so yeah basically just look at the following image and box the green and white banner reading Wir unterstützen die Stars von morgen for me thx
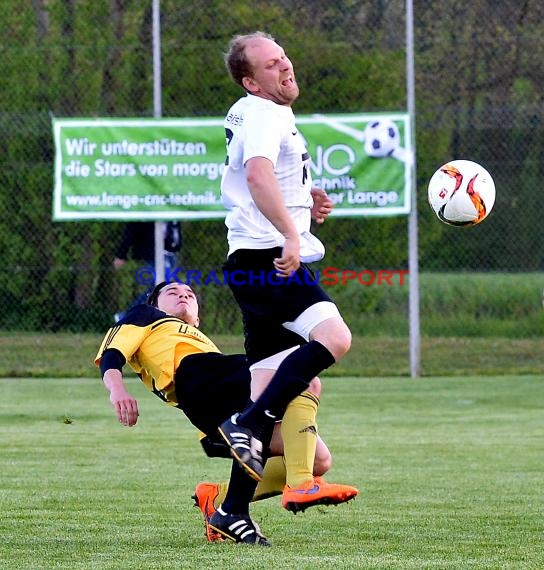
[53,113,412,221]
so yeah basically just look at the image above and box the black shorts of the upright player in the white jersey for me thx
[223,247,331,364]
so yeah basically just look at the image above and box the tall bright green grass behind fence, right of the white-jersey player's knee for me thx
[327,271,544,339]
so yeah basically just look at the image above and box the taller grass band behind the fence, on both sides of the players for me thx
[4,270,544,339]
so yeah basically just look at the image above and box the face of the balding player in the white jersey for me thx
[244,38,299,105]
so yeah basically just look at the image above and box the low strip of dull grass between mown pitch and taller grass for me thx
[0,332,544,378]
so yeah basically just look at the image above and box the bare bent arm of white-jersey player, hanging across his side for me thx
[245,156,300,277]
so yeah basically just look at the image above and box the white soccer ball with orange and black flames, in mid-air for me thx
[428,160,495,226]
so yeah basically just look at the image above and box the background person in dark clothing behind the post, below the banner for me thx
[113,222,182,322]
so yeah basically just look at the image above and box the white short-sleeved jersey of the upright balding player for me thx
[221,95,325,262]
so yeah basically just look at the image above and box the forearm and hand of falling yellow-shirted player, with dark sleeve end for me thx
[100,349,138,427]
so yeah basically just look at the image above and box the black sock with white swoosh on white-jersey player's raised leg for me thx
[237,340,335,435]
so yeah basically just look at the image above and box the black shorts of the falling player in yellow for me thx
[176,352,251,436]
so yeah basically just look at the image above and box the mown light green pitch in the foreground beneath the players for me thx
[0,375,544,570]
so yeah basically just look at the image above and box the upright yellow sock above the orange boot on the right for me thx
[281,392,319,487]
